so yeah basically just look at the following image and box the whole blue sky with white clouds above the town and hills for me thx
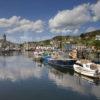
[0,0,100,43]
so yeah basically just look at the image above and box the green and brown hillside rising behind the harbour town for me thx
[22,30,100,45]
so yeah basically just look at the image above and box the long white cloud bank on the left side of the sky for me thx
[0,16,44,33]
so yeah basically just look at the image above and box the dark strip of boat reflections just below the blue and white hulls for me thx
[47,63,100,85]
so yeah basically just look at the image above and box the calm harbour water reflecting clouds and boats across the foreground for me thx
[0,51,100,100]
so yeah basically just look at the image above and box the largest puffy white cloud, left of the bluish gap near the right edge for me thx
[49,4,92,33]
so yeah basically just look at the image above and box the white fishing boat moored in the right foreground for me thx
[73,60,100,78]
